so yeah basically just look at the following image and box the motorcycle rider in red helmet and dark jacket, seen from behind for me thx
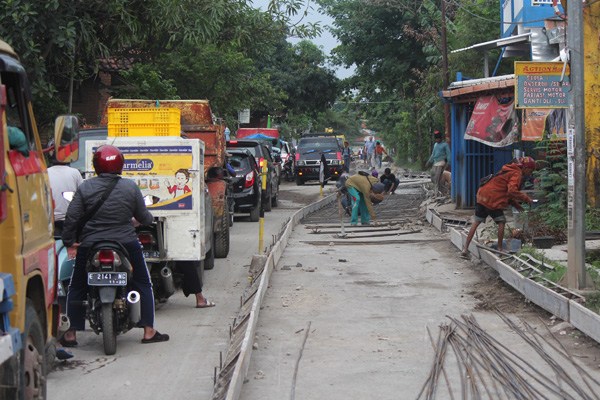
[61,145,169,347]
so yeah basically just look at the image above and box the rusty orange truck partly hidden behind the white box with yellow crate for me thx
[102,98,233,258]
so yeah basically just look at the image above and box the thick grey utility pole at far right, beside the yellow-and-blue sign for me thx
[567,0,586,290]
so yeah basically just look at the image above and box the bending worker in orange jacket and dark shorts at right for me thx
[461,157,535,258]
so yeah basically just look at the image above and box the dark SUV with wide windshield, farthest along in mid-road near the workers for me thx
[296,136,344,185]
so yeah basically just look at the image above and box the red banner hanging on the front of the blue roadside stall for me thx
[465,96,518,147]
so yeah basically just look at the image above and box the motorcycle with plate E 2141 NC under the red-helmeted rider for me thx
[84,241,141,355]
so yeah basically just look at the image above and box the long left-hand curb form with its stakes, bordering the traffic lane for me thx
[211,193,337,400]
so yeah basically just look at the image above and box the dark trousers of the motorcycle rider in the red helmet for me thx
[67,240,154,331]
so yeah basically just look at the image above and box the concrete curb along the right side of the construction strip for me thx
[427,209,600,343]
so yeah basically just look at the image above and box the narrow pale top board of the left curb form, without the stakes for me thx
[225,194,337,400]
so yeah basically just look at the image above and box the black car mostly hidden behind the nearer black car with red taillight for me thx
[227,140,281,211]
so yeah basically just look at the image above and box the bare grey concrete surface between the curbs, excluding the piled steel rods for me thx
[240,182,600,400]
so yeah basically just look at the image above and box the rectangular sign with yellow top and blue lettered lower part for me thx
[515,61,571,108]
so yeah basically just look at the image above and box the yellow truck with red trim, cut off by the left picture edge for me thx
[0,40,62,399]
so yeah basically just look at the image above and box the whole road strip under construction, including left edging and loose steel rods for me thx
[213,175,600,400]
